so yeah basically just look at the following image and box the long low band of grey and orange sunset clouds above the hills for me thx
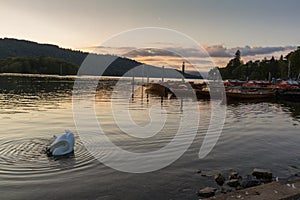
[79,43,297,68]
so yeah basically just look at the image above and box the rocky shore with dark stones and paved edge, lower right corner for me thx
[197,168,300,200]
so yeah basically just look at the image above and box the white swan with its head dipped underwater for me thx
[46,130,75,156]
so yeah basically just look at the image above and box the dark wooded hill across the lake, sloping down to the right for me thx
[0,38,199,78]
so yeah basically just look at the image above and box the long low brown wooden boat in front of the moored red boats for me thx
[226,87,275,100]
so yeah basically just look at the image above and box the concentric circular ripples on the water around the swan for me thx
[0,138,96,178]
